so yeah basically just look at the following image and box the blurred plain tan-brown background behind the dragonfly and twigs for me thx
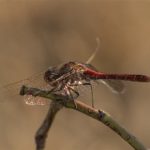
[0,0,150,150]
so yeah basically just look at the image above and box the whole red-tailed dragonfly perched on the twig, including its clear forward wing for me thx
[1,61,150,107]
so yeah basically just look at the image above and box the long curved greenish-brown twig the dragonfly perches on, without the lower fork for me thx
[20,86,146,150]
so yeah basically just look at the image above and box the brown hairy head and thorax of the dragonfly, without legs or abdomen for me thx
[44,62,85,88]
